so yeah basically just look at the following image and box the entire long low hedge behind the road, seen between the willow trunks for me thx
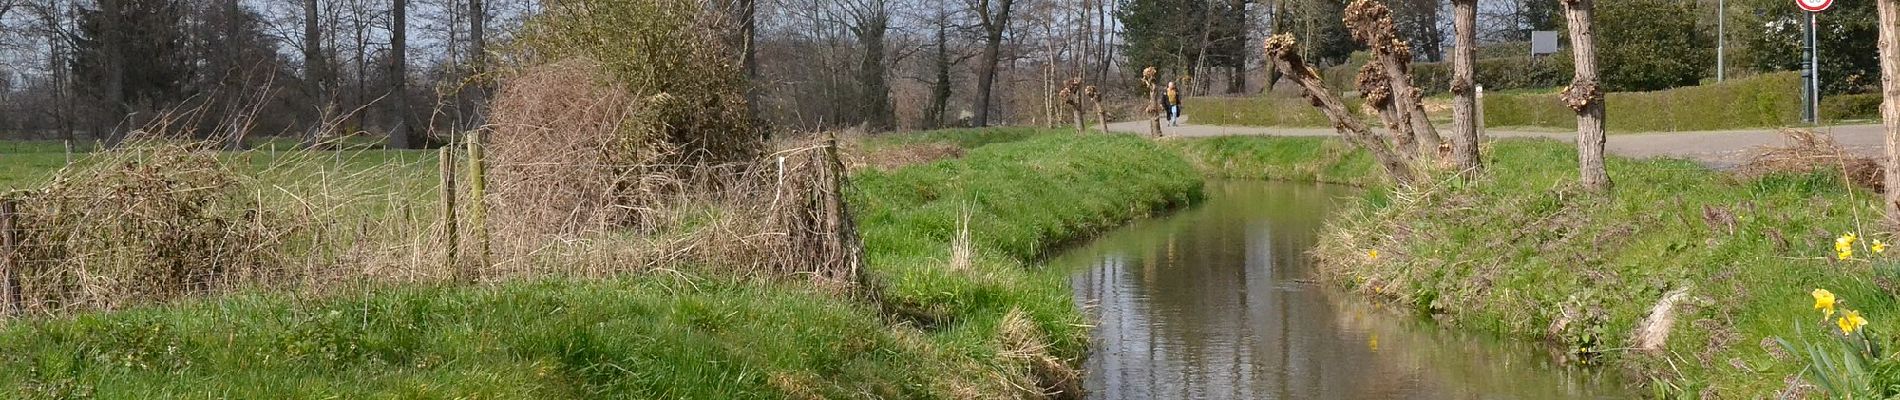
[1184,72,1801,133]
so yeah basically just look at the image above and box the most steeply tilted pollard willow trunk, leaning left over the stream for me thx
[1262,34,1414,186]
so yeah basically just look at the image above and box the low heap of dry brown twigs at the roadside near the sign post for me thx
[1735,129,1887,191]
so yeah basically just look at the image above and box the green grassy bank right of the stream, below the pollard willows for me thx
[1176,138,1900,398]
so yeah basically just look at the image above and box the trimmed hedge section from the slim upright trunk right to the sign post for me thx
[1484,72,1801,133]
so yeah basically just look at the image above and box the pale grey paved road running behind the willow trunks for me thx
[1108,121,1881,169]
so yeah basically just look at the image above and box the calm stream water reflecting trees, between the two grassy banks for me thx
[1055,182,1628,398]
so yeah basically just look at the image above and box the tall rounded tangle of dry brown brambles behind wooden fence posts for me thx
[485,59,676,254]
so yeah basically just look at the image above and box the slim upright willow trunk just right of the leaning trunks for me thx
[1452,0,1484,174]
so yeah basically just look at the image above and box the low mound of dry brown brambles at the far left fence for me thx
[11,142,281,313]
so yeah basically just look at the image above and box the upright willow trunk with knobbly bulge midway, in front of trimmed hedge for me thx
[1564,0,1609,191]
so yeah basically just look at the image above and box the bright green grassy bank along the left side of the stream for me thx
[0,133,1201,398]
